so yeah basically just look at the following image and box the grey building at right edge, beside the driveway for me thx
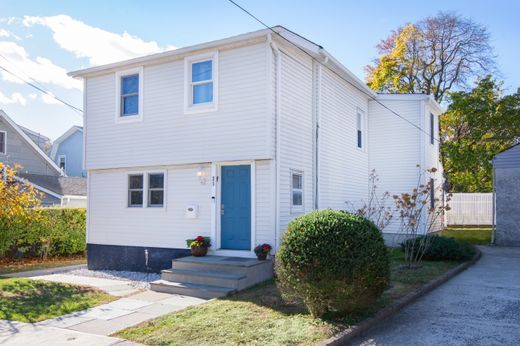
[493,144,520,246]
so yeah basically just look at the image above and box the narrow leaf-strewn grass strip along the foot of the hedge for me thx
[0,256,86,275]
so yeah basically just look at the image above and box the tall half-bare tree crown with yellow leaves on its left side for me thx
[366,12,495,102]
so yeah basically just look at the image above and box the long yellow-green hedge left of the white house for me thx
[0,208,86,258]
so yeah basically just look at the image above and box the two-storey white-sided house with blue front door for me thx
[71,26,442,271]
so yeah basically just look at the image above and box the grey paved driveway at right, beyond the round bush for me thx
[353,247,520,346]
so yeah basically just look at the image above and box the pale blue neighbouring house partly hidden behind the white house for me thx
[50,126,87,177]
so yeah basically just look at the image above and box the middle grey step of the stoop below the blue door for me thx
[161,268,246,289]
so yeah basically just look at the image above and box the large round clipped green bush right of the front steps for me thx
[276,210,390,317]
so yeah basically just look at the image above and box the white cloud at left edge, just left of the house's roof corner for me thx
[0,41,83,90]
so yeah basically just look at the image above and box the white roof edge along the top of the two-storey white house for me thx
[69,25,376,97]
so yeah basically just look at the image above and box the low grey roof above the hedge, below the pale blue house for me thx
[17,173,87,198]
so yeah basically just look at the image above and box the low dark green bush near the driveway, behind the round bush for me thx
[401,235,476,261]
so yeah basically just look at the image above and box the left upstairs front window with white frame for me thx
[116,68,143,122]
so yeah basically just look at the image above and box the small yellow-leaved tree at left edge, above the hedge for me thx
[0,162,43,256]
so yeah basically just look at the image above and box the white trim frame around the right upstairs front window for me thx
[184,52,219,114]
